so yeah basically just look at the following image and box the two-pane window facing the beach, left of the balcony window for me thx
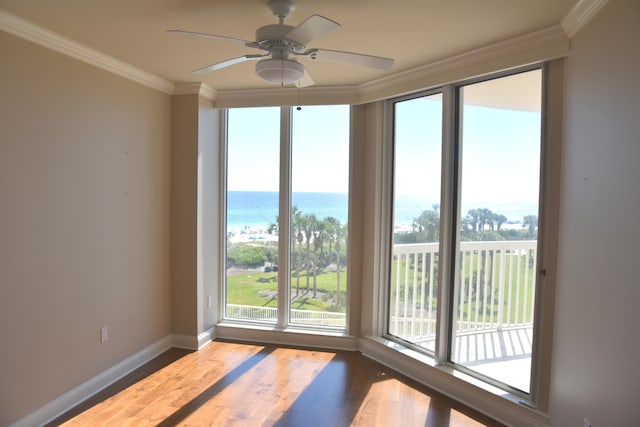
[225,106,350,329]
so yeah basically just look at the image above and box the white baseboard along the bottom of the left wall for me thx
[9,336,173,427]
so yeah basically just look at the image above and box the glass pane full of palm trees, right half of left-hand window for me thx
[289,105,350,328]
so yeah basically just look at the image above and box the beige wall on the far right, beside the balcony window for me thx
[551,0,640,427]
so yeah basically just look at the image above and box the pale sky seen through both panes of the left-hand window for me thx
[228,105,349,193]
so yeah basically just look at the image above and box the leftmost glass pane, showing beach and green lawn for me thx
[225,107,280,323]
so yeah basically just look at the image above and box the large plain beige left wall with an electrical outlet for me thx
[0,33,171,425]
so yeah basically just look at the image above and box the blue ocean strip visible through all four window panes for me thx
[227,191,537,236]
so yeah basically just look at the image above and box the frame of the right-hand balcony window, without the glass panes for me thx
[375,63,557,409]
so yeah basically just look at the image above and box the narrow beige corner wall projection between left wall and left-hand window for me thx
[171,94,221,338]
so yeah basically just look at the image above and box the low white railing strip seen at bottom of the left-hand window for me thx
[226,304,347,327]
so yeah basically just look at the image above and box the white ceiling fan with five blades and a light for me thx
[168,0,394,87]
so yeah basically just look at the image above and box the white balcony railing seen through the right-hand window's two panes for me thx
[389,240,536,343]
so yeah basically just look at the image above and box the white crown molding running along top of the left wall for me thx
[0,9,174,94]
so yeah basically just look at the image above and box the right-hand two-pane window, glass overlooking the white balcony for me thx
[386,69,542,395]
